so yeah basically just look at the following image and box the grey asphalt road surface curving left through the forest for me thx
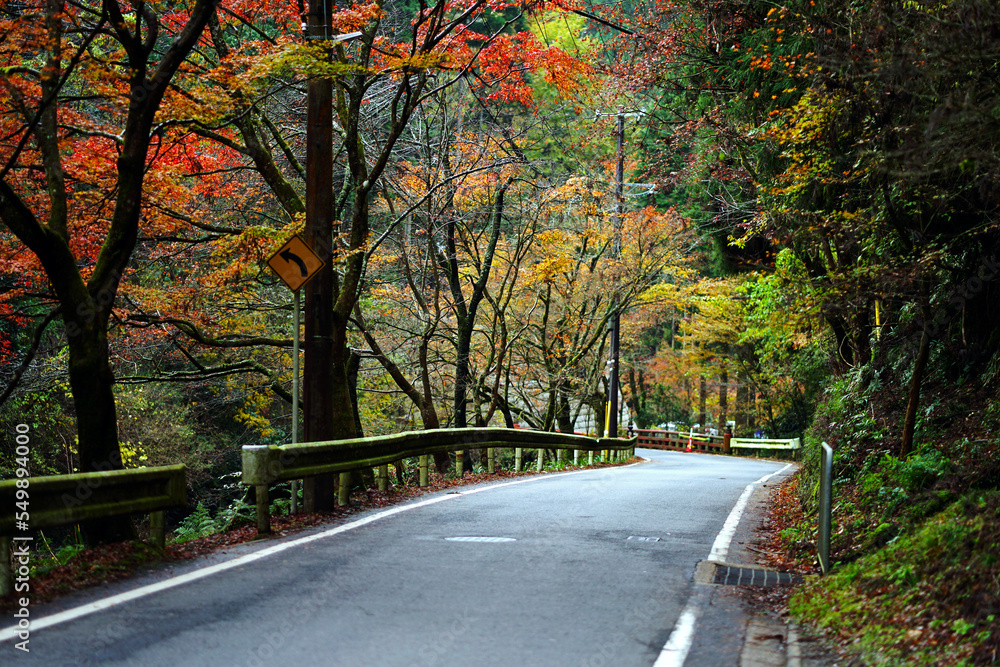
[0,450,782,667]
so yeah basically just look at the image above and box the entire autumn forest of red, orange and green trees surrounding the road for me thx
[0,0,1000,664]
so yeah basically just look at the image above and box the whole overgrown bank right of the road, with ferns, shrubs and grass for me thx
[776,370,1000,665]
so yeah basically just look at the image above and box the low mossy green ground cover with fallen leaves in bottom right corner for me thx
[790,494,1000,665]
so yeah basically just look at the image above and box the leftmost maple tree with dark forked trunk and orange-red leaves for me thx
[0,0,215,540]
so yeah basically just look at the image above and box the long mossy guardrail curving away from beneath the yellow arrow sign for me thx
[242,428,637,533]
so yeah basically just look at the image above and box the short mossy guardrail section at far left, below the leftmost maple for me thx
[0,465,187,595]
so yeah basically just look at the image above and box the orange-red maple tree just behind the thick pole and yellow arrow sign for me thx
[0,3,592,460]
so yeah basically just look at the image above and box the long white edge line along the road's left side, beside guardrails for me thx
[0,463,639,642]
